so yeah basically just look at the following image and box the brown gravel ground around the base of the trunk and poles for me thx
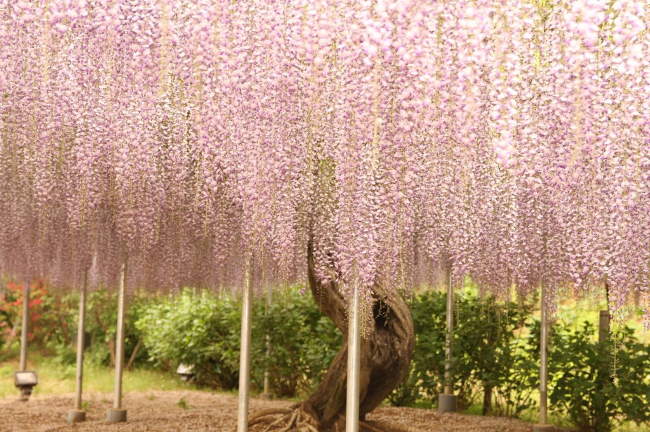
[0,391,532,432]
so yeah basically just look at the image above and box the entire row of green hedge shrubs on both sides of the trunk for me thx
[7,287,650,432]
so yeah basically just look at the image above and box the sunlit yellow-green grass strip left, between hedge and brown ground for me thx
[0,354,195,398]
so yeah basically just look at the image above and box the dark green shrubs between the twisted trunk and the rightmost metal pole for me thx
[389,291,537,415]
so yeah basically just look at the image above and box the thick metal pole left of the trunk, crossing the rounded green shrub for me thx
[237,259,252,432]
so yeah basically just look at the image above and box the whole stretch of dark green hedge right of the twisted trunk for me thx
[389,292,650,432]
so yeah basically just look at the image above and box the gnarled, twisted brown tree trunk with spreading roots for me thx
[251,241,415,432]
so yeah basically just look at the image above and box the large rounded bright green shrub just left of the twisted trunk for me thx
[136,289,342,397]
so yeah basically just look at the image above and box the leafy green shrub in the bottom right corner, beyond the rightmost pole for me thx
[549,322,650,432]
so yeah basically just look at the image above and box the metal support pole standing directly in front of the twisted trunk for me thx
[345,283,361,432]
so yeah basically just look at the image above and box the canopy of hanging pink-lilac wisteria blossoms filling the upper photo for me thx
[0,0,650,322]
